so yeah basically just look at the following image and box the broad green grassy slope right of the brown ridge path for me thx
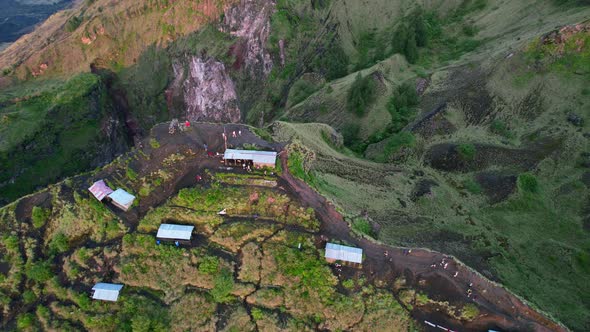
[275,21,590,331]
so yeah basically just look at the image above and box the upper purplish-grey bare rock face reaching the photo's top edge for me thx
[222,0,275,77]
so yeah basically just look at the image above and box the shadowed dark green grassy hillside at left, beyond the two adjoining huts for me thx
[0,74,128,203]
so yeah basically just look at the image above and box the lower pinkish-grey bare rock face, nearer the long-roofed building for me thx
[169,57,241,122]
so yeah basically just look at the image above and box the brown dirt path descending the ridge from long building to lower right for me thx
[280,153,566,331]
